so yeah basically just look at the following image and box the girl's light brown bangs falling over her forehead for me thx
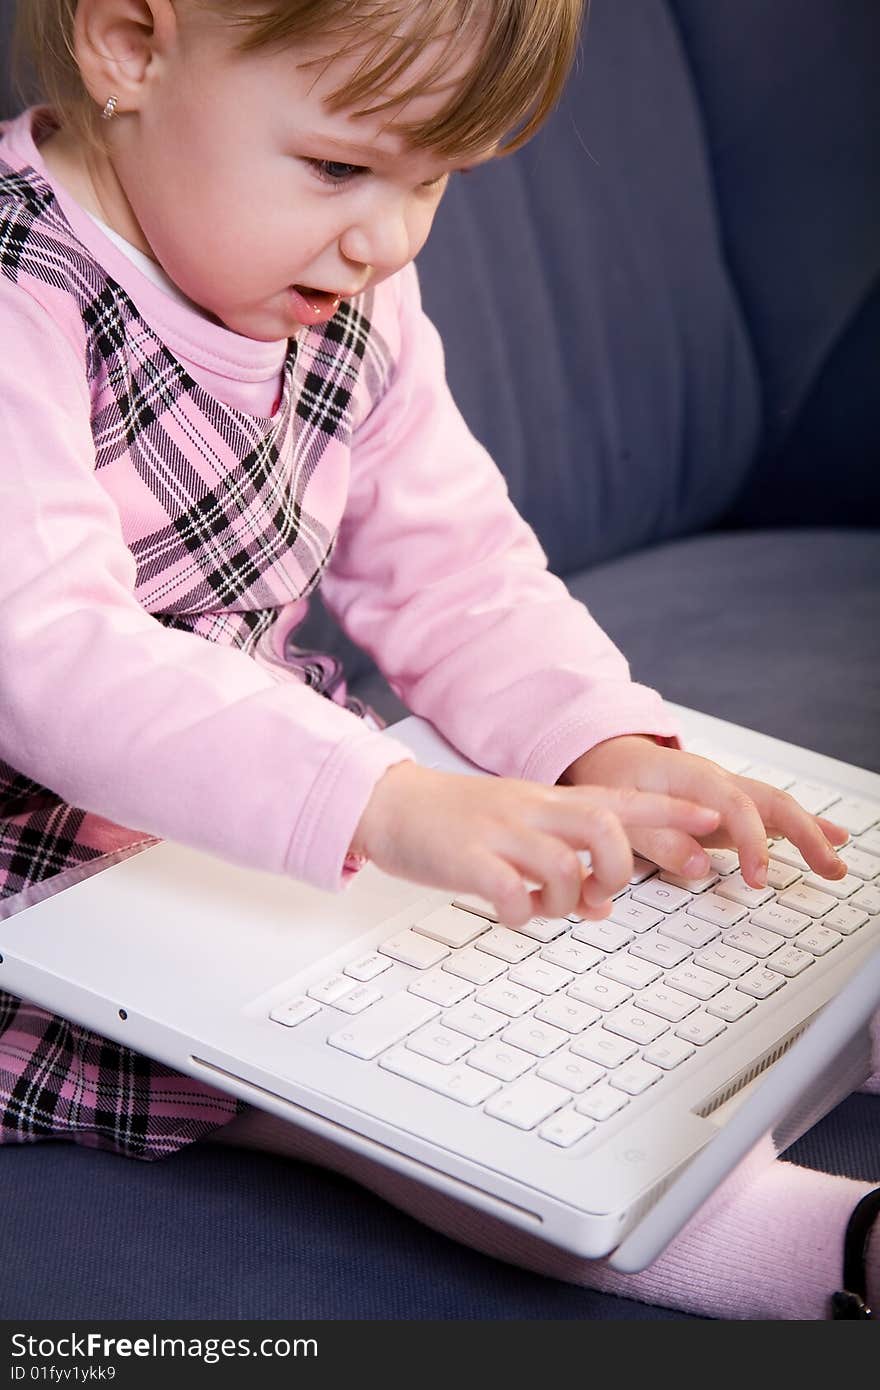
[222,0,584,158]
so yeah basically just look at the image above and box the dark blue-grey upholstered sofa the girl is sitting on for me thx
[0,0,880,1319]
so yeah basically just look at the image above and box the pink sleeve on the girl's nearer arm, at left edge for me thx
[0,282,412,890]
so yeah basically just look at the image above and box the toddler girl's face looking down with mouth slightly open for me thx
[113,21,488,341]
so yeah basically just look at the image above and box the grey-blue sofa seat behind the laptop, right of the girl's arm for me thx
[569,528,880,771]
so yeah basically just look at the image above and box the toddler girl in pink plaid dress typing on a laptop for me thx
[0,0,880,1318]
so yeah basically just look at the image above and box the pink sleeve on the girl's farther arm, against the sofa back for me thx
[321,265,683,783]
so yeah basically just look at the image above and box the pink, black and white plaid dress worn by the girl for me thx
[0,149,393,1159]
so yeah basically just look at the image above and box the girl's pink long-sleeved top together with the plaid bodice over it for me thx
[0,110,681,890]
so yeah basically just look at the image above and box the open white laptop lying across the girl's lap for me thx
[0,705,880,1270]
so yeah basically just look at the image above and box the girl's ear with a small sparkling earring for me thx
[74,0,178,114]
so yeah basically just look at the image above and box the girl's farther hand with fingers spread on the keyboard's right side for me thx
[564,734,848,888]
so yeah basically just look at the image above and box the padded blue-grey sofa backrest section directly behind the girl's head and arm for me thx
[418,0,759,575]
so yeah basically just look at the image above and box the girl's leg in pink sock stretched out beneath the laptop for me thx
[211,1109,880,1321]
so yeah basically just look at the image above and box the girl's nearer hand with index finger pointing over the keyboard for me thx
[352,762,719,927]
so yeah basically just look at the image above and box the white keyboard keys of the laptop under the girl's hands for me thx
[268,742,880,1148]
